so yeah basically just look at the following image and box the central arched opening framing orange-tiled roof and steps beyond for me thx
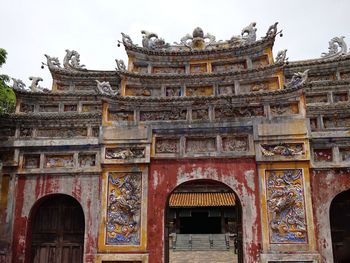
[165,180,243,263]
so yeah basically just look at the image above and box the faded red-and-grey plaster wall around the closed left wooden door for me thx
[12,175,100,263]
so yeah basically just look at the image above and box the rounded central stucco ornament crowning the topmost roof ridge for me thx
[175,27,216,50]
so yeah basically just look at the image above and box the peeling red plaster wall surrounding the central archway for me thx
[148,158,261,263]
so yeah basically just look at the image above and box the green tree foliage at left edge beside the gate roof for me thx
[0,48,16,114]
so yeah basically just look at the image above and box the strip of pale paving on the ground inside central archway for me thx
[169,250,238,263]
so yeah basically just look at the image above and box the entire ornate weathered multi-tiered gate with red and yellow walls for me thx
[0,23,350,263]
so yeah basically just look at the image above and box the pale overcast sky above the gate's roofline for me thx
[0,0,350,88]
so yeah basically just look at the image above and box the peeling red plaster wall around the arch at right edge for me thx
[310,169,350,263]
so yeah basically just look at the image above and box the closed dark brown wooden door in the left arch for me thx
[27,194,85,263]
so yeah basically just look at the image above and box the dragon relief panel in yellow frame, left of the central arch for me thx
[105,172,142,245]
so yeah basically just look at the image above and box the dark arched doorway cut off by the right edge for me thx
[329,190,350,263]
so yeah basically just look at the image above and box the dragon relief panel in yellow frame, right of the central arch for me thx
[265,169,308,244]
